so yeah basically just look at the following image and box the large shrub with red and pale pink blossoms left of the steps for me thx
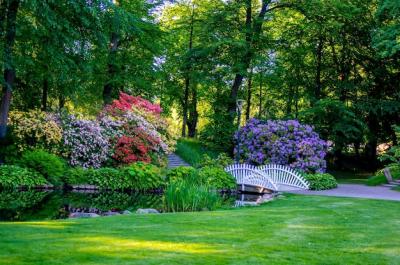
[99,93,172,164]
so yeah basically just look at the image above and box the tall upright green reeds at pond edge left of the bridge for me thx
[163,174,221,212]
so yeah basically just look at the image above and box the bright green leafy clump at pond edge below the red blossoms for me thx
[123,162,164,191]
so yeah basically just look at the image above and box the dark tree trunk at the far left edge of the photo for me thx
[0,0,19,140]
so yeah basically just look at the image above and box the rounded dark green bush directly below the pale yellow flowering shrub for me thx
[18,150,65,184]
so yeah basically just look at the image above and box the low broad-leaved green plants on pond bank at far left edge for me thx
[0,165,47,188]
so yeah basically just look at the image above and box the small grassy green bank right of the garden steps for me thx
[175,138,219,166]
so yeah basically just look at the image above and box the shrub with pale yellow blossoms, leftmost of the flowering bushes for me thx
[9,110,62,153]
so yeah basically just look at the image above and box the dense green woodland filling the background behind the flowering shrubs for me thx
[0,0,400,169]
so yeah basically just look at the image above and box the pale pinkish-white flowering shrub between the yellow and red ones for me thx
[63,116,110,168]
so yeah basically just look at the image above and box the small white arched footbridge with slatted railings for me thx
[225,164,309,191]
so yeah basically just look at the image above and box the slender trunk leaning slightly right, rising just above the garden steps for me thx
[181,5,194,137]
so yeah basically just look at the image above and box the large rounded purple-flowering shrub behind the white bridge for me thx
[235,119,328,172]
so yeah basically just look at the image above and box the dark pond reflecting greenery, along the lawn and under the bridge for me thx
[0,190,272,221]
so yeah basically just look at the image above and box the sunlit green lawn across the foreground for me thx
[0,195,400,265]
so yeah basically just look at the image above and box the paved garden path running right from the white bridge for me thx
[291,184,400,201]
